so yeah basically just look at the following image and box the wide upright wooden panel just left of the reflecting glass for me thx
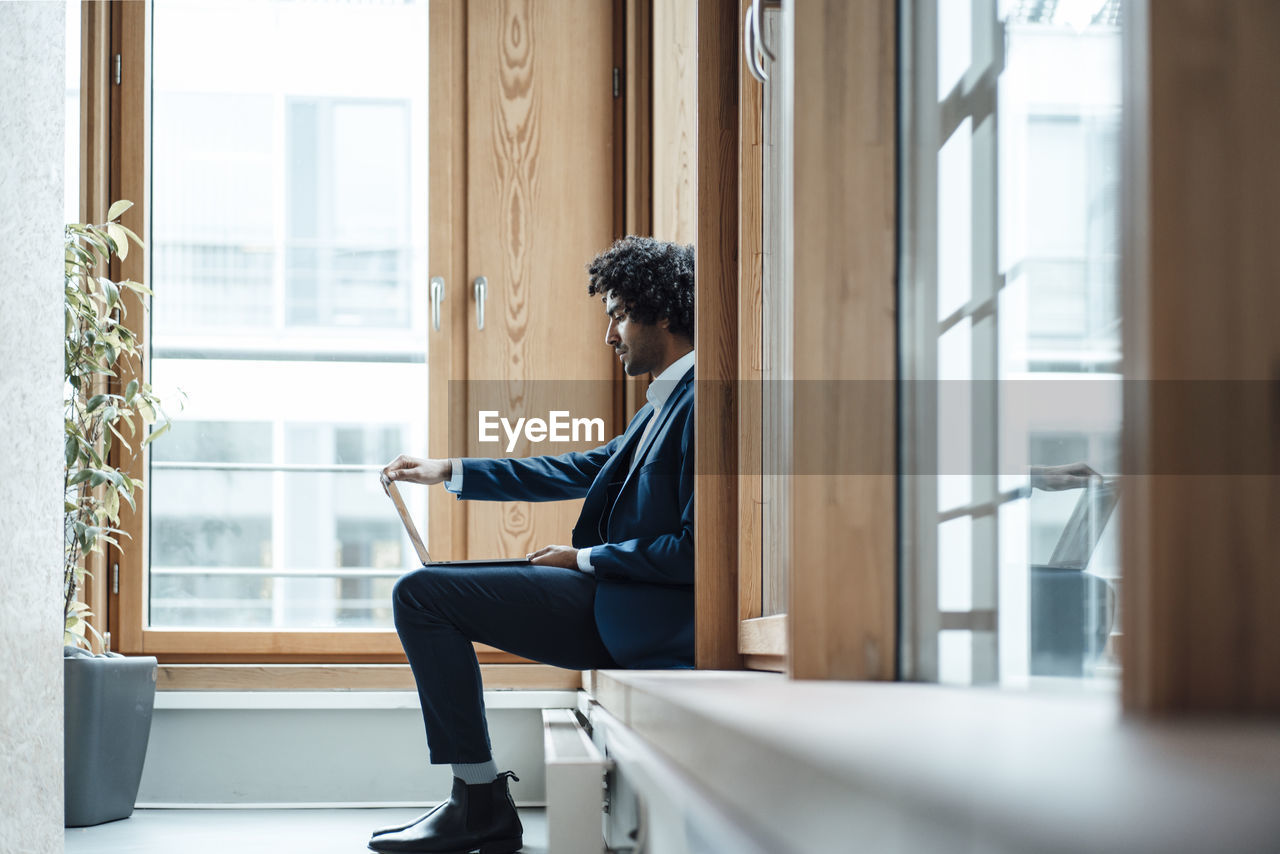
[788,0,896,679]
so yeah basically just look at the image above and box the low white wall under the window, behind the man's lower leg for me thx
[138,691,555,807]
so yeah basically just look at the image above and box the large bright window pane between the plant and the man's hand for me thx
[148,0,428,629]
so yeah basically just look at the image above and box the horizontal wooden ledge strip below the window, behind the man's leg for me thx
[156,665,582,691]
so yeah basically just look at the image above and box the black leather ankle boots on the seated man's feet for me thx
[369,771,525,854]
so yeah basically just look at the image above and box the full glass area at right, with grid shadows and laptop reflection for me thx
[900,0,1123,685]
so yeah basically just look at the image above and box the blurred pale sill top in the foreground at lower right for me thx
[591,671,1280,853]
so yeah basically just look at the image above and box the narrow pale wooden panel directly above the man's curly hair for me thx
[653,0,699,243]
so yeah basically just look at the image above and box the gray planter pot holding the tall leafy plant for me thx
[63,656,156,827]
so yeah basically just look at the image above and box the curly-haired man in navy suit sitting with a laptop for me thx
[369,237,694,854]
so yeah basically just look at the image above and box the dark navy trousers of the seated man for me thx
[392,563,617,763]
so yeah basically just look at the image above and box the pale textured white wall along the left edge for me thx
[0,1,65,854]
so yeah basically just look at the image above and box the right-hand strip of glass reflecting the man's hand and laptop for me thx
[1000,1,1121,681]
